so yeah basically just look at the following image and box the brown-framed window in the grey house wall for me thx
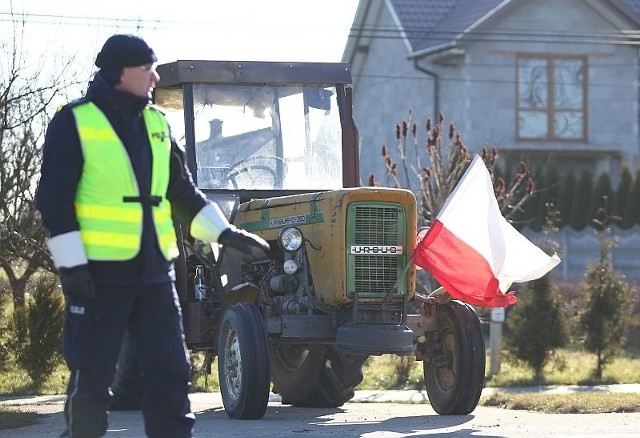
[516,55,587,141]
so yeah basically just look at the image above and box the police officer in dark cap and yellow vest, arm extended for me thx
[36,34,269,438]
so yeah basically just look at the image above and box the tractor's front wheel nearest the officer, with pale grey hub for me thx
[218,302,270,420]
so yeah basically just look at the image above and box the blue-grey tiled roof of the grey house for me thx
[388,0,640,56]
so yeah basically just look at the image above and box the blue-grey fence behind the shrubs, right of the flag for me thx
[522,225,640,284]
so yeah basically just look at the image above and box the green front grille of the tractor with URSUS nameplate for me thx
[347,203,406,297]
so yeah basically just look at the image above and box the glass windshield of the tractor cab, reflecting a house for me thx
[155,83,342,190]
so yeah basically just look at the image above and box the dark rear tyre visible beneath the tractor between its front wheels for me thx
[271,345,367,408]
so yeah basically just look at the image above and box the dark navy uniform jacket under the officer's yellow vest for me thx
[36,72,206,286]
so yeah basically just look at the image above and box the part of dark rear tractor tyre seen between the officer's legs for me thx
[109,333,144,411]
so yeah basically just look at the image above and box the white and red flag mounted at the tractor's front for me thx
[414,155,560,307]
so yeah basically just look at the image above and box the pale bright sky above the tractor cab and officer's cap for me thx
[0,0,358,69]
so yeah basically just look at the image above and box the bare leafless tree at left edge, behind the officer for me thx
[0,6,84,307]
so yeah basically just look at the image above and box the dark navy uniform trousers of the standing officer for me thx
[64,282,195,438]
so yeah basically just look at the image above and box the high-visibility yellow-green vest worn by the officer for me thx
[72,102,178,261]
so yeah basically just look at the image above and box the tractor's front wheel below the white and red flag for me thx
[423,301,485,415]
